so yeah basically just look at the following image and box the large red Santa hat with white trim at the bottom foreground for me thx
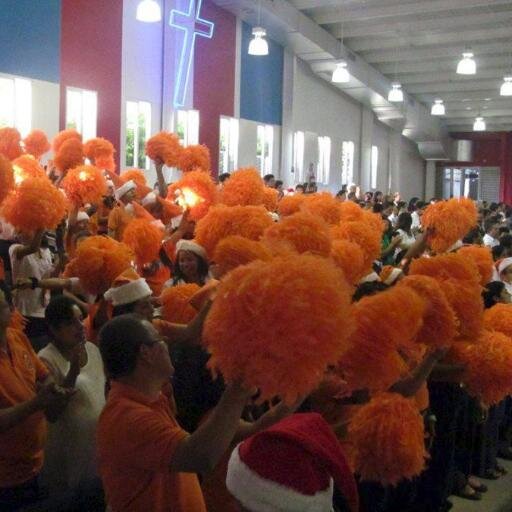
[226,413,358,512]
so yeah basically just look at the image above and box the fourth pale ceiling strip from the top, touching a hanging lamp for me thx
[361,39,510,64]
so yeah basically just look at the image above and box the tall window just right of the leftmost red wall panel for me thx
[126,101,151,169]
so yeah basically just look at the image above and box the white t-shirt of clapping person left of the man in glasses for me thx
[38,342,105,491]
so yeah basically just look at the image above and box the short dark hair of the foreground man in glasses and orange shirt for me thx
[99,315,152,379]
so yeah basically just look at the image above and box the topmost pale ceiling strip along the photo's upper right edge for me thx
[312,0,510,25]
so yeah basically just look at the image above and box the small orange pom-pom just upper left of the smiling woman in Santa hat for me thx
[123,219,164,265]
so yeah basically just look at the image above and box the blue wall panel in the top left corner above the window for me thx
[0,0,60,82]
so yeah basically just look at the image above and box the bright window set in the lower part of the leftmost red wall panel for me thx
[66,87,98,140]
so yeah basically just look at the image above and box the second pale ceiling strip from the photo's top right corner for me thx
[325,9,512,39]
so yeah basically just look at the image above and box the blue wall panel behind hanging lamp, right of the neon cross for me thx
[240,23,284,125]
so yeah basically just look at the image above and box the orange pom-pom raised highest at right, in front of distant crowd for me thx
[421,198,478,253]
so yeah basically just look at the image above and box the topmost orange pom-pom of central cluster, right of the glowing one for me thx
[220,167,265,206]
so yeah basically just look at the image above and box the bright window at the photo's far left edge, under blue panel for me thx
[0,77,32,137]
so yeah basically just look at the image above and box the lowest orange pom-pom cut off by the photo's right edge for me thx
[450,331,512,406]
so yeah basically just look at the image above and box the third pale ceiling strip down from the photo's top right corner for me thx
[344,24,512,53]
